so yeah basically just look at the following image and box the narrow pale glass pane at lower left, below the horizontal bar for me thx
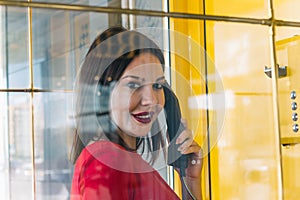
[7,93,33,200]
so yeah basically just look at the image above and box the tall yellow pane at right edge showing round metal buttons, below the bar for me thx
[276,27,300,199]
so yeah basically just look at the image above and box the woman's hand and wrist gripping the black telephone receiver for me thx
[176,120,203,180]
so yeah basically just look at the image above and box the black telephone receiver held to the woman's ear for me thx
[164,83,188,177]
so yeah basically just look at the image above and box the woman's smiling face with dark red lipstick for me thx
[110,53,165,137]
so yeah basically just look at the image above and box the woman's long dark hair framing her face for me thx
[71,27,165,163]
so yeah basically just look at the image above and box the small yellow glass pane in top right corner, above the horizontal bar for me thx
[274,0,300,21]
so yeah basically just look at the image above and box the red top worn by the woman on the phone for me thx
[71,141,179,200]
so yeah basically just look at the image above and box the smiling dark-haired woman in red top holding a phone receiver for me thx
[71,27,202,200]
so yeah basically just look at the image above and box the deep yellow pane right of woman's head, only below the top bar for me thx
[168,21,210,199]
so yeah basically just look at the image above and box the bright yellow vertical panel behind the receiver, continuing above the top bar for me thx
[170,0,208,196]
